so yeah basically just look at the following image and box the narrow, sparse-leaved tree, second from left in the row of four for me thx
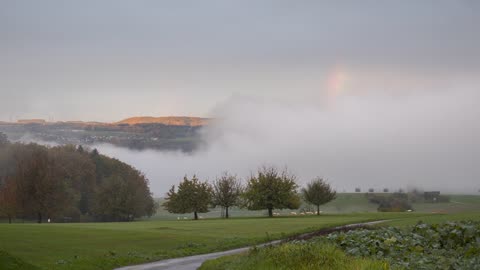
[212,172,243,218]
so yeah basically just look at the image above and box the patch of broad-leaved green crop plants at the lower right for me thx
[327,221,480,269]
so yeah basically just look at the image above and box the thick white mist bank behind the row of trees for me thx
[92,90,480,196]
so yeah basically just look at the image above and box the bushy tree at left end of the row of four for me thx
[163,175,212,220]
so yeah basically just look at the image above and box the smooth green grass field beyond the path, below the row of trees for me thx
[0,194,480,270]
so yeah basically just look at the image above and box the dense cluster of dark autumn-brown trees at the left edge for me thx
[0,134,155,222]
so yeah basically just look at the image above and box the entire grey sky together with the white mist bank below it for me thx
[0,0,480,196]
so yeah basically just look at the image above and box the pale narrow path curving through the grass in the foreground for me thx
[116,220,386,270]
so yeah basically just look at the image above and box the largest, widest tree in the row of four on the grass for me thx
[244,167,300,217]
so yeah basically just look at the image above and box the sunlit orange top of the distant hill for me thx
[114,116,211,127]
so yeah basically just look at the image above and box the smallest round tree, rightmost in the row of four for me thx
[302,177,336,215]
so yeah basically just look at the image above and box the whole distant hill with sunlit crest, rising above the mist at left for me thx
[0,116,211,152]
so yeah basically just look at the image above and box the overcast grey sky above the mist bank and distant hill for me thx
[0,0,480,121]
